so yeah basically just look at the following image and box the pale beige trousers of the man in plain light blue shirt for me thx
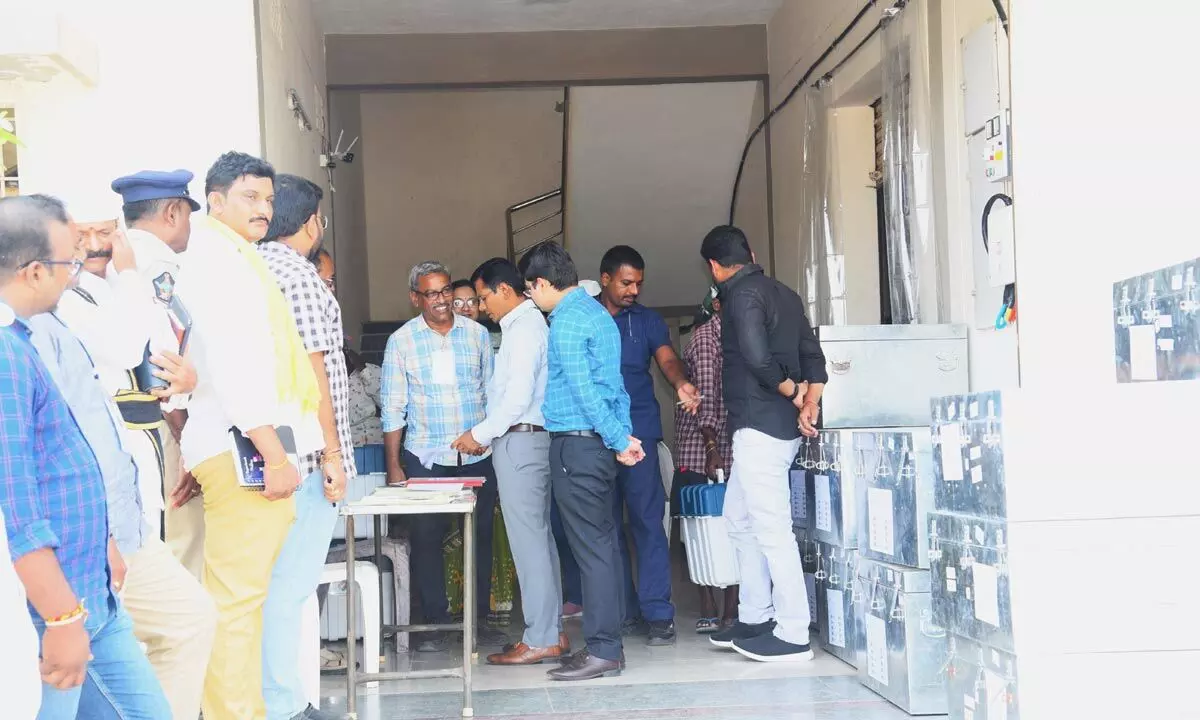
[122,538,217,720]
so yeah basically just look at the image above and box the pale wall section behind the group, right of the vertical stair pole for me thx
[566,82,768,307]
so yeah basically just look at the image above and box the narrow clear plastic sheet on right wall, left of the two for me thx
[800,89,846,325]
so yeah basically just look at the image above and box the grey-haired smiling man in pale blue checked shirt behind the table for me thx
[380,262,508,652]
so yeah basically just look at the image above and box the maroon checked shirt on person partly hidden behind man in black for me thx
[676,316,733,478]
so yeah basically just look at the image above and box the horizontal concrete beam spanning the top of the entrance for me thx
[325,25,767,86]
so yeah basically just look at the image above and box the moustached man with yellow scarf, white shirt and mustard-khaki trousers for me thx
[173,152,324,720]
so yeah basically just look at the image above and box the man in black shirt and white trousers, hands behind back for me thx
[700,226,828,661]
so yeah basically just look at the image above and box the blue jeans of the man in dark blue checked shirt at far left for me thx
[37,606,170,720]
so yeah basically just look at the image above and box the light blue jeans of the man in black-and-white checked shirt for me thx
[263,469,336,720]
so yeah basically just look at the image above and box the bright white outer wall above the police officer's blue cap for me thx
[0,0,262,209]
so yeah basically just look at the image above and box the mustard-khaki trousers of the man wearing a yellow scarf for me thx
[192,452,295,720]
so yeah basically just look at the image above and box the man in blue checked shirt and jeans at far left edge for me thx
[0,196,170,720]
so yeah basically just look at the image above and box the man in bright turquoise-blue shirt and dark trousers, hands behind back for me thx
[520,242,646,680]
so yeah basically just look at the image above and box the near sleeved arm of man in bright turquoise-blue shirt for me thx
[550,316,632,452]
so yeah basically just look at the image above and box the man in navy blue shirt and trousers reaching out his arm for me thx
[600,245,700,646]
